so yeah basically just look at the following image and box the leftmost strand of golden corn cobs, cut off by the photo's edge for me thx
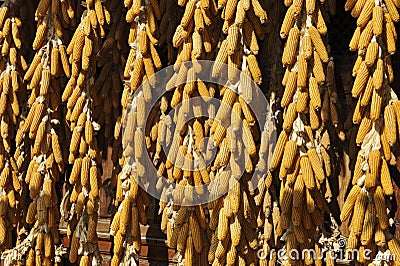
[0,1,28,254]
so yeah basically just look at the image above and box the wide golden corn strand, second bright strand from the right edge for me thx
[270,0,338,265]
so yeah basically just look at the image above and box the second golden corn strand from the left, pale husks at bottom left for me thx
[3,1,70,265]
